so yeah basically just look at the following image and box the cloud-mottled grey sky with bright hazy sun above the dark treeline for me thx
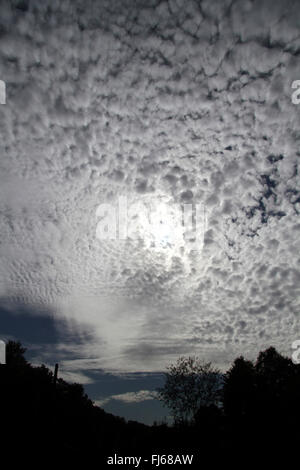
[0,0,300,423]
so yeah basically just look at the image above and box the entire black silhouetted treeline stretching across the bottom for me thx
[0,341,300,468]
